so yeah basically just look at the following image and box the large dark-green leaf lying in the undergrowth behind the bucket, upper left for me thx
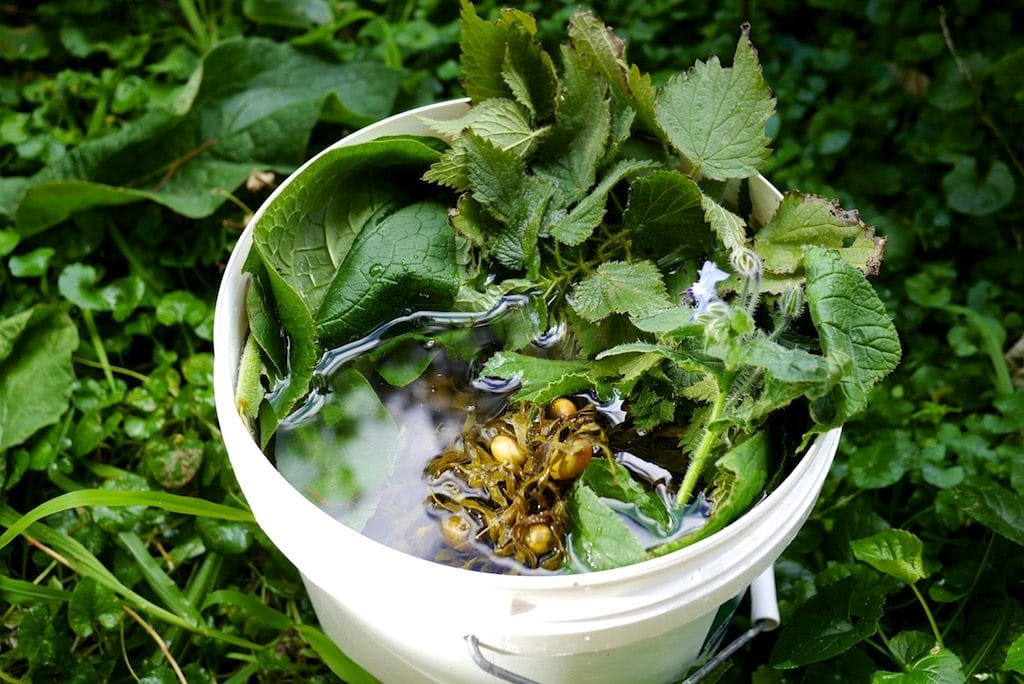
[15,38,399,236]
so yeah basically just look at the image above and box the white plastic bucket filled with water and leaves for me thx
[214,100,840,684]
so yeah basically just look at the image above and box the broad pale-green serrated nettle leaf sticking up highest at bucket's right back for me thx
[655,29,775,180]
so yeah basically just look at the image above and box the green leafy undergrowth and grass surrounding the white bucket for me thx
[0,0,1024,683]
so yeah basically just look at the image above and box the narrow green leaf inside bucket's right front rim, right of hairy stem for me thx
[654,432,768,555]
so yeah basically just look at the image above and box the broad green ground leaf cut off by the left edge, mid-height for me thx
[0,306,78,453]
